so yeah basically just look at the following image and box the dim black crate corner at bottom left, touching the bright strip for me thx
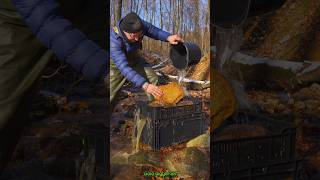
[77,123,109,180]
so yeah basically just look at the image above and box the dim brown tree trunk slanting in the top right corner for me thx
[257,0,320,60]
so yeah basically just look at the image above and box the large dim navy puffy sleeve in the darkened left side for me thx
[12,0,109,80]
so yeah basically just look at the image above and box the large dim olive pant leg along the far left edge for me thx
[0,9,52,173]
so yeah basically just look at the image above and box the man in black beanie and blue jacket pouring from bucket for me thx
[110,13,183,109]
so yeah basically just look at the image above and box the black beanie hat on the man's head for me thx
[120,12,143,33]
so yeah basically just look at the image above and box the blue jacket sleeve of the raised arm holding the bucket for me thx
[142,20,171,41]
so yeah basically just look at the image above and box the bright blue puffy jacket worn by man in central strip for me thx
[110,19,171,87]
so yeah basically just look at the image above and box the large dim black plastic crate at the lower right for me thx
[210,113,297,179]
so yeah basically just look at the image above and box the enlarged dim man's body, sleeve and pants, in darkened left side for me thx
[0,0,109,174]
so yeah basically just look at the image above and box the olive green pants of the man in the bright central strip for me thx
[110,52,158,112]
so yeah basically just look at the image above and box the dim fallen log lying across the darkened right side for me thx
[222,53,320,90]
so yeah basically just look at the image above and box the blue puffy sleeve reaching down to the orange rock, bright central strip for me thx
[110,31,146,87]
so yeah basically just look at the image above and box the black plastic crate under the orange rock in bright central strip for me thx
[136,98,205,149]
